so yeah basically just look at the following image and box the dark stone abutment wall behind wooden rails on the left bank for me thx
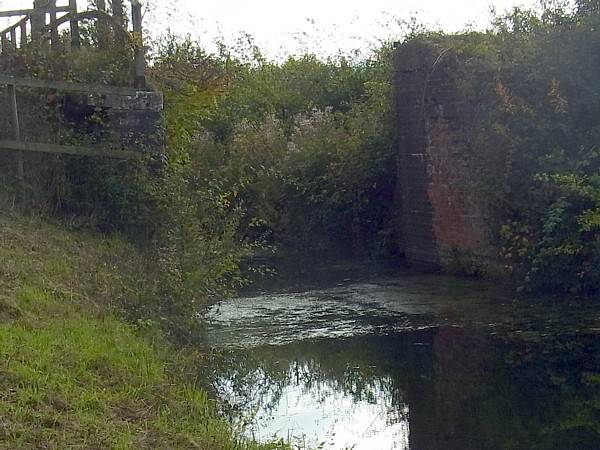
[0,89,164,154]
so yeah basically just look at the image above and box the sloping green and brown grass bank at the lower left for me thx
[0,216,281,450]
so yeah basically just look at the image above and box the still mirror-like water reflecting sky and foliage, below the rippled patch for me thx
[214,327,600,450]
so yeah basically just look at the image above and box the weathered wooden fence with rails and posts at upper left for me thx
[0,0,162,174]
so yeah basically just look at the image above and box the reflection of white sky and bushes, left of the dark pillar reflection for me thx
[214,330,430,450]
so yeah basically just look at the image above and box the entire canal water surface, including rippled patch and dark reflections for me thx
[207,273,600,450]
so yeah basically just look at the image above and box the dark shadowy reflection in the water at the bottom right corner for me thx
[426,328,600,449]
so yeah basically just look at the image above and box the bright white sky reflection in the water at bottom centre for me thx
[218,363,409,450]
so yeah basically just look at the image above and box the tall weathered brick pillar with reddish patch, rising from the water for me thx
[395,41,493,268]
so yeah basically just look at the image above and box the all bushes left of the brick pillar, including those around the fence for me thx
[2,18,397,317]
